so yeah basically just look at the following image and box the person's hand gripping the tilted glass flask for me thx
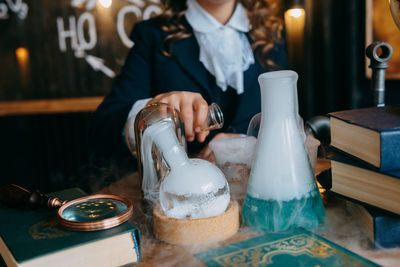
[147,91,209,143]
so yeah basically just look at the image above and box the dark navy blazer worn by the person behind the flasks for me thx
[91,18,286,155]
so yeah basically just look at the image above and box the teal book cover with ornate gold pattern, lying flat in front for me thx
[196,229,379,267]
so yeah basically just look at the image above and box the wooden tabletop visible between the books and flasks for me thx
[101,159,400,266]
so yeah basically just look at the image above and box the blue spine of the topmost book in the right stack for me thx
[380,130,400,172]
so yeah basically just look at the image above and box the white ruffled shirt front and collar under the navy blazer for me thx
[185,0,254,94]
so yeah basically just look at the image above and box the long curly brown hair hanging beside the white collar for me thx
[160,0,283,66]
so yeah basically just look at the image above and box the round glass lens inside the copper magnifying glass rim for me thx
[61,198,127,222]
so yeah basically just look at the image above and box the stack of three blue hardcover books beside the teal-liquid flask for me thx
[328,107,400,248]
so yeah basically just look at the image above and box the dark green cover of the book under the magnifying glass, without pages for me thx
[0,188,140,263]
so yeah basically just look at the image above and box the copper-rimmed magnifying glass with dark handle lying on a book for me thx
[0,184,133,231]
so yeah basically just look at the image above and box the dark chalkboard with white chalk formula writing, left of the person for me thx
[0,0,161,101]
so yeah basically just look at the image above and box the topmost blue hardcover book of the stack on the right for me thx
[329,106,400,171]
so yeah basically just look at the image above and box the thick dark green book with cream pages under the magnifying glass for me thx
[0,188,140,267]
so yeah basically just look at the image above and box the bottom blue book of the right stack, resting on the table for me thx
[346,201,400,248]
